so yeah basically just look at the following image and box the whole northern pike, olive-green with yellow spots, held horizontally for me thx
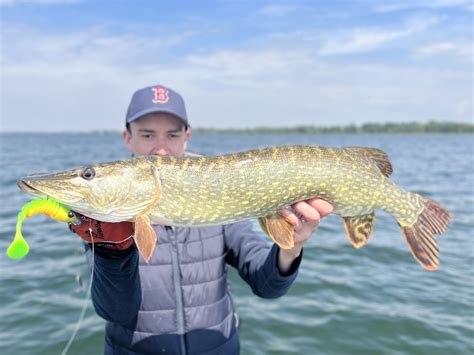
[18,145,451,271]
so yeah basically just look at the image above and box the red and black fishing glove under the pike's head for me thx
[69,212,133,250]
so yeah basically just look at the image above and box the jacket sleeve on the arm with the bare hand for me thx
[224,221,302,298]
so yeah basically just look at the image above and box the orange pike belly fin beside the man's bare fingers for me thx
[258,213,295,249]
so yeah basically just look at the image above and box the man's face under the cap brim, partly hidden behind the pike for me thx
[123,113,191,157]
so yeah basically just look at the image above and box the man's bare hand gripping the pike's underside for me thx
[278,198,333,273]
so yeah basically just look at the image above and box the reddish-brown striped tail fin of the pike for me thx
[402,199,451,271]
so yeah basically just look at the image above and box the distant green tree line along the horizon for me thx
[193,121,474,134]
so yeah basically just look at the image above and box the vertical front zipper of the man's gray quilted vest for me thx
[166,226,187,355]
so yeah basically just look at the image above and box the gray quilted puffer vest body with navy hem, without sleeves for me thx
[107,226,238,354]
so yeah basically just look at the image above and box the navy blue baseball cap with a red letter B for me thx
[125,85,189,128]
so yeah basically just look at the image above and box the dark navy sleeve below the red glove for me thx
[86,245,142,324]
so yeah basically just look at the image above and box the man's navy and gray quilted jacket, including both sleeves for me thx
[87,222,301,354]
